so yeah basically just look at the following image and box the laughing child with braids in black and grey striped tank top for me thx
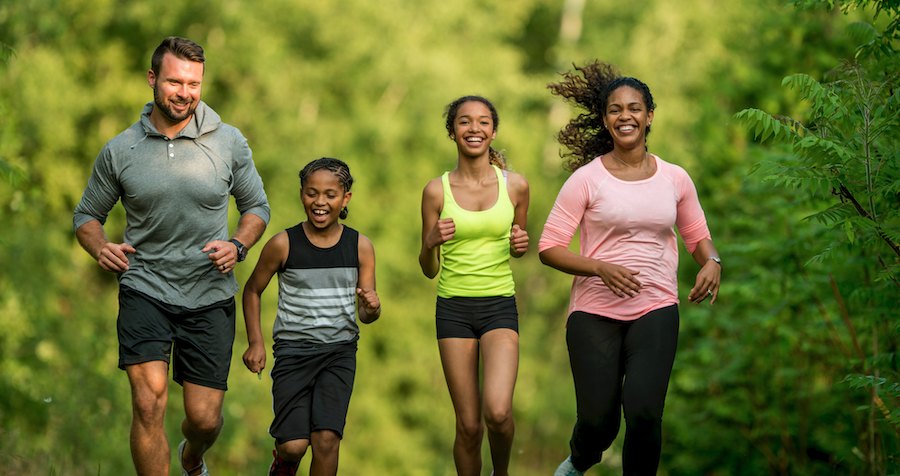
[243,158,381,476]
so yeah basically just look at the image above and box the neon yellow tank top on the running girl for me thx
[437,165,516,298]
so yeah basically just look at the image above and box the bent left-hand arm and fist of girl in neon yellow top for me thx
[419,178,456,279]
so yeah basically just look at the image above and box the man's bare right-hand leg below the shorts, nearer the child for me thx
[181,382,225,474]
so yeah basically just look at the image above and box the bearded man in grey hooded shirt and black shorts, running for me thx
[74,37,269,476]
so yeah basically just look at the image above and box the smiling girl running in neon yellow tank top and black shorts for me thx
[419,96,529,476]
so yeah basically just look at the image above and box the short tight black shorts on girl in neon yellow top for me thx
[435,296,519,339]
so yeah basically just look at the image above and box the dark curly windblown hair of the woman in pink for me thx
[547,60,656,172]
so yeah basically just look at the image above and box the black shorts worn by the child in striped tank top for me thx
[269,341,356,444]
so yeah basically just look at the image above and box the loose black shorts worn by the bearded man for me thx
[116,286,235,390]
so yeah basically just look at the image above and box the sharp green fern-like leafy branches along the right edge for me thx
[735,0,900,474]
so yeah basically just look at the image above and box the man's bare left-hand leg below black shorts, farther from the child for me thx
[125,360,170,476]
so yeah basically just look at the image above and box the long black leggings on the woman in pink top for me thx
[566,305,678,475]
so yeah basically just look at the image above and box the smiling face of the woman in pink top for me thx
[603,86,653,148]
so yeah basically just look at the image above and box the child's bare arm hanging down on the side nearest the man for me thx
[242,231,290,374]
